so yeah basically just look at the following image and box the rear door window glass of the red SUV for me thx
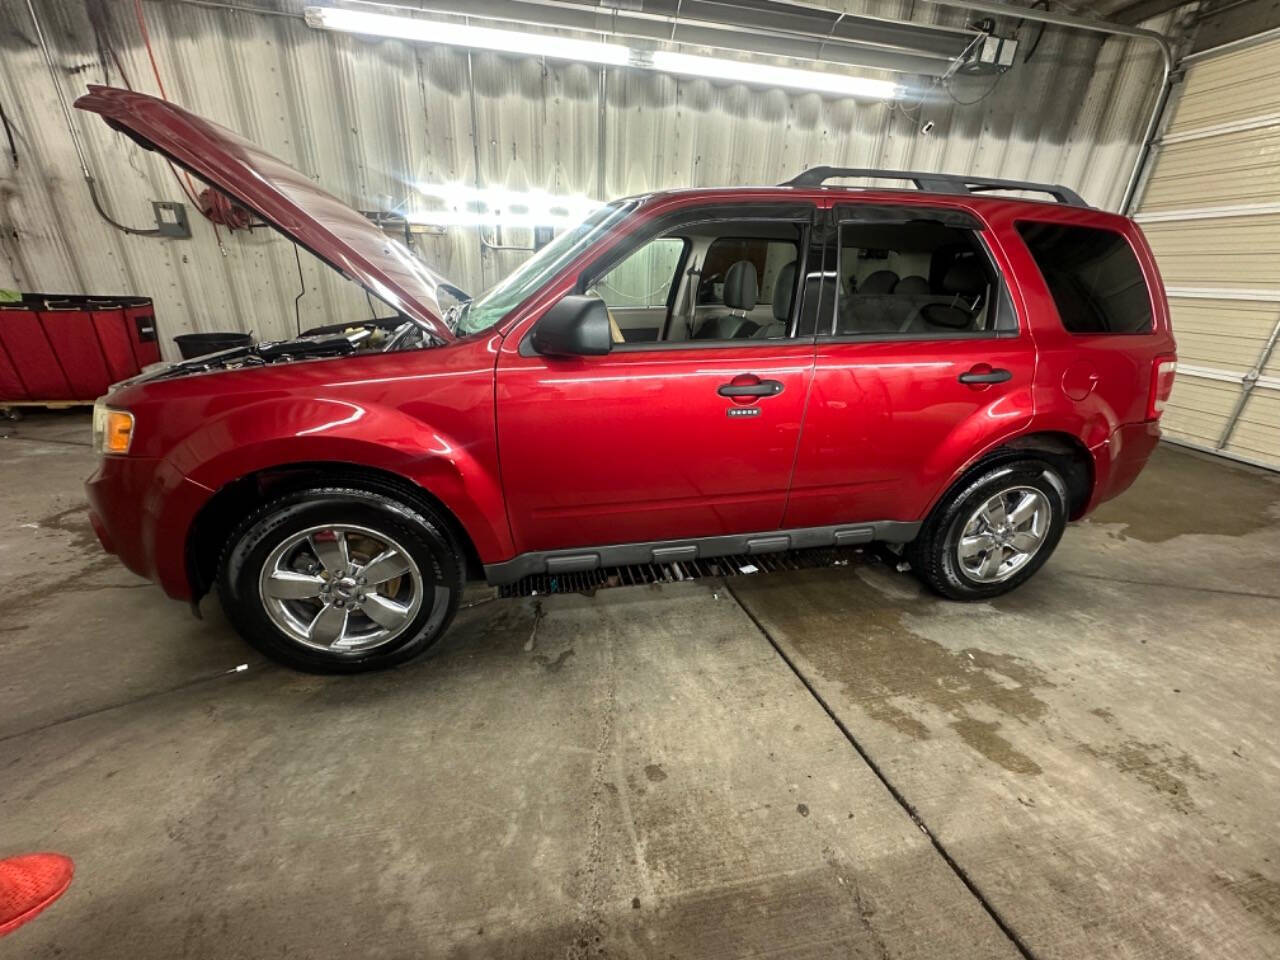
[836,219,1016,338]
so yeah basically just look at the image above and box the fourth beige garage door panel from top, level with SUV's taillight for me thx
[1169,297,1280,372]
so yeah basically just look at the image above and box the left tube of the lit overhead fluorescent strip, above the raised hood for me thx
[305,6,631,67]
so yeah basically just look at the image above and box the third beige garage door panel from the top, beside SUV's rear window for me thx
[1142,214,1280,291]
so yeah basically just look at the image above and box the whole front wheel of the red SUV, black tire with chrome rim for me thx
[218,486,465,673]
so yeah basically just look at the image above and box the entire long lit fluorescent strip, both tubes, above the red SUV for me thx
[305,6,899,100]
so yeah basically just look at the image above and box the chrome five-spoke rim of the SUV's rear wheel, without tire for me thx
[956,486,1053,584]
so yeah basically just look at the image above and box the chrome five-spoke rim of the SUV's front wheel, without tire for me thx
[259,524,430,654]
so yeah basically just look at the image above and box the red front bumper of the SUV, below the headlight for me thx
[84,457,214,600]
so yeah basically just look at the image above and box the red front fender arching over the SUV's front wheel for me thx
[165,396,512,562]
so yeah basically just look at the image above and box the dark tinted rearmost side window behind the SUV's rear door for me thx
[1018,221,1151,333]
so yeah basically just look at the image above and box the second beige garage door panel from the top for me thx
[1142,126,1280,212]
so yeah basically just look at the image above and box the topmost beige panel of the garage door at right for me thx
[1167,44,1280,134]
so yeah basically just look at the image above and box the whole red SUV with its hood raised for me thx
[77,87,1174,671]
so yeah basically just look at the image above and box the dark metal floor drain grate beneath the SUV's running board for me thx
[498,547,867,598]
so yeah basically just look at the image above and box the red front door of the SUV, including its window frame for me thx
[497,204,820,553]
